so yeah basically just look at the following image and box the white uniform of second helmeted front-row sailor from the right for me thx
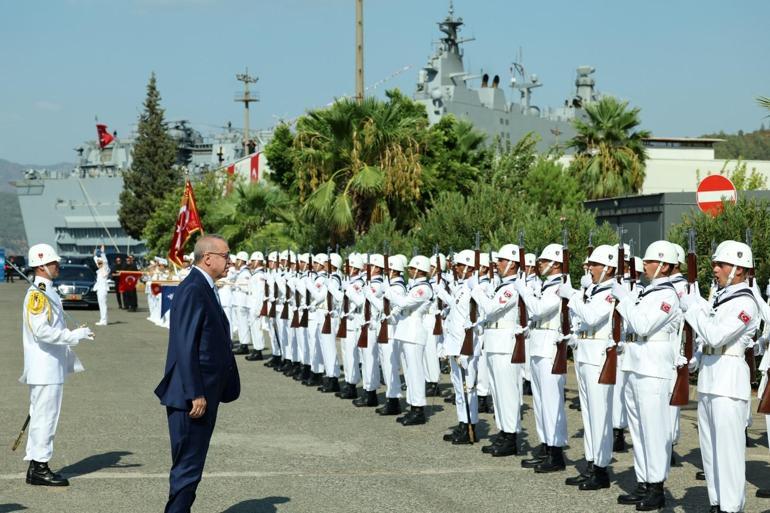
[616,277,679,483]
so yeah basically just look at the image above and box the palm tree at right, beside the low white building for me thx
[569,96,650,199]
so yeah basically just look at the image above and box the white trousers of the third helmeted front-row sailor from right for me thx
[577,363,615,467]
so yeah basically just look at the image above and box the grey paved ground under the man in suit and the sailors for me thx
[0,283,770,513]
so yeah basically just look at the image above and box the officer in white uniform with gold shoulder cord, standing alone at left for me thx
[19,244,94,486]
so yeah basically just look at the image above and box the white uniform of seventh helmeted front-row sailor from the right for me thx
[385,278,433,407]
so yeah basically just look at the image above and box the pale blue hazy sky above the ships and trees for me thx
[0,0,770,164]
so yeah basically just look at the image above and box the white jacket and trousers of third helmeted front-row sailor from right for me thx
[568,279,618,467]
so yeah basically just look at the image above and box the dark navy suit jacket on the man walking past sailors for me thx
[155,269,241,410]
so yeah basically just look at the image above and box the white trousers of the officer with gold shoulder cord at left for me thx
[24,383,64,463]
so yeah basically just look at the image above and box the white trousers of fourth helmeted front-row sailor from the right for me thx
[530,355,567,447]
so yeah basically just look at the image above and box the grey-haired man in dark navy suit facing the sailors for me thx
[155,235,241,513]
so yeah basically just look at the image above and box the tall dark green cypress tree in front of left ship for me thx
[118,72,182,240]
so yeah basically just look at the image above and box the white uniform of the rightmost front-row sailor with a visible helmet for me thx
[685,283,759,511]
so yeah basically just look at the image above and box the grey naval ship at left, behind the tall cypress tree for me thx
[14,121,262,256]
